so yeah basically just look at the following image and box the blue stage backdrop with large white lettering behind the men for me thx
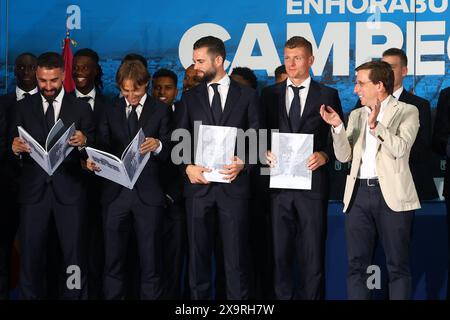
[0,0,450,112]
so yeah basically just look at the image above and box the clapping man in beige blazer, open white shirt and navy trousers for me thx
[320,61,420,299]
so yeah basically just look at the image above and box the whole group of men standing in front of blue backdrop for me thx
[0,36,450,300]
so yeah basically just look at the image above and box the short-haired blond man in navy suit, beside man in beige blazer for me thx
[261,36,342,300]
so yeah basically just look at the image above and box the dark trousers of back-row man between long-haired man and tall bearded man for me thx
[163,201,187,299]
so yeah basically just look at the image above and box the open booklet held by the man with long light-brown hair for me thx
[86,129,150,189]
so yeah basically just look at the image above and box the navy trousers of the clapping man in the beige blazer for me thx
[345,180,414,300]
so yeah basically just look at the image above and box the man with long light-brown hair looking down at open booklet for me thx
[87,60,172,299]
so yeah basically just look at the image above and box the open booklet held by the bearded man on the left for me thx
[17,119,75,176]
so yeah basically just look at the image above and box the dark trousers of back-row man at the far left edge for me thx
[0,195,20,300]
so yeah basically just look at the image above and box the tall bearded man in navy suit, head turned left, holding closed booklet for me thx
[178,36,260,300]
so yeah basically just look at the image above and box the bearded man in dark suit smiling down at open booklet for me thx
[11,52,94,299]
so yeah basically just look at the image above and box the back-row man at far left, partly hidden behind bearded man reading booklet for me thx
[0,53,38,300]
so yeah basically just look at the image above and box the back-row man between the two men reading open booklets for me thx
[72,48,110,299]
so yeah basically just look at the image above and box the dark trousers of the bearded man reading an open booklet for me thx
[20,184,87,299]
